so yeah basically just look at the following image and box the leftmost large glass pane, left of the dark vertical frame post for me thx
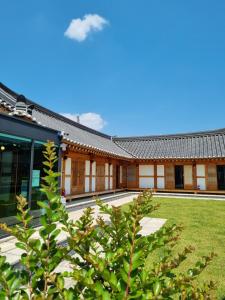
[0,133,31,218]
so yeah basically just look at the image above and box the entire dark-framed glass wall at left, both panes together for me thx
[0,133,58,225]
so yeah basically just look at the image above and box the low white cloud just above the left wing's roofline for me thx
[61,112,107,130]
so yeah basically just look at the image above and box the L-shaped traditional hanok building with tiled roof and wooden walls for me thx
[0,84,225,220]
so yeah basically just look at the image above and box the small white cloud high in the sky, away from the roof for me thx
[64,14,108,42]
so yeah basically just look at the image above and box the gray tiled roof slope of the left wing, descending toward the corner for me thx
[0,83,132,158]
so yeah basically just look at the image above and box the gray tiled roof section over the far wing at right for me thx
[114,129,225,159]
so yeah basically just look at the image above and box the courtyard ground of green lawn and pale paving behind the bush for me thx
[1,193,225,299]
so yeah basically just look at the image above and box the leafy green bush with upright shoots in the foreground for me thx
[0,142,214,300]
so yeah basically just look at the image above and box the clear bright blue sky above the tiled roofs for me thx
[0,0,225,136]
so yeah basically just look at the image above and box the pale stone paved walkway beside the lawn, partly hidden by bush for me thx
[0,193,166,264]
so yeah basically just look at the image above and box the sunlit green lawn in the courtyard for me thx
[129,198,225,299]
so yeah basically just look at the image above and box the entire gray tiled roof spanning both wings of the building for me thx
[0,83,225,159]
